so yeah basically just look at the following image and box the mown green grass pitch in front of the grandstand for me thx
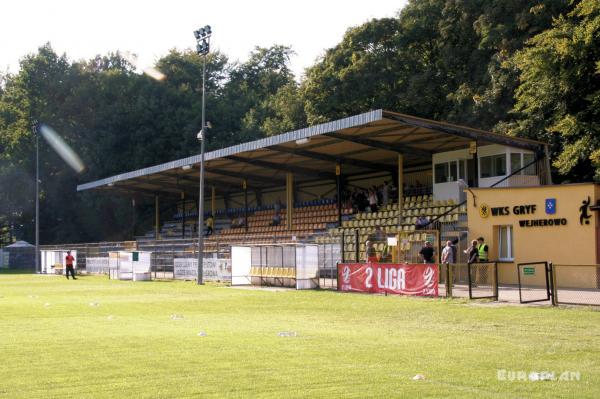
[0,273,600,399]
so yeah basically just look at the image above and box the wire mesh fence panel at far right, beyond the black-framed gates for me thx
[550,264,600,306]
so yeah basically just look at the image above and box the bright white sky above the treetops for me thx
[0,0,407,78]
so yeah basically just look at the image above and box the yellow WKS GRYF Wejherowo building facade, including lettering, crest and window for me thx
[466,183,600,288]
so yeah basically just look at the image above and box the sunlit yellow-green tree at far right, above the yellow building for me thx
[508,0,600,181]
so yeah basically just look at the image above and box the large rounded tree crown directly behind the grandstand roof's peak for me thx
[301,0,565,129]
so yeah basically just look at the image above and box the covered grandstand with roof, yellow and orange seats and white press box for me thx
[77,110,552,260]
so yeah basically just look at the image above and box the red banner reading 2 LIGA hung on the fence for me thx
[338,263,439,296]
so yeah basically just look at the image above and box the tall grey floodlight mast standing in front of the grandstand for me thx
[193,25,212,285]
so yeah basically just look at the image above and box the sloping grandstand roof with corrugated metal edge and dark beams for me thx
[77,109,546,196]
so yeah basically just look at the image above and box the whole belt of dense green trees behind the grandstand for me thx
[0,0,600,242]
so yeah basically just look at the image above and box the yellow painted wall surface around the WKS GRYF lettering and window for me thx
[467,183,600,288]
